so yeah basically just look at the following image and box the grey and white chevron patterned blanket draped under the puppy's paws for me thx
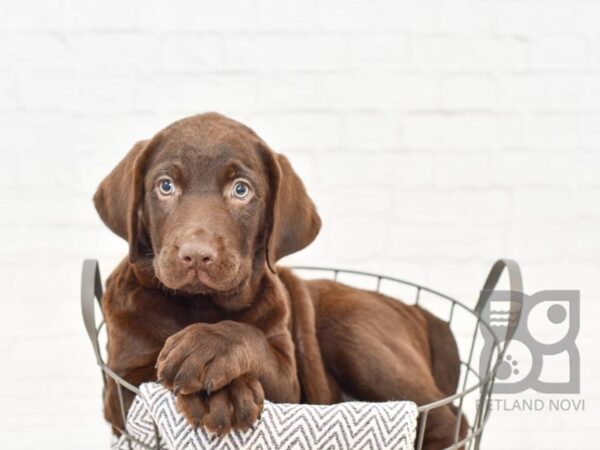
[112,383,418,450]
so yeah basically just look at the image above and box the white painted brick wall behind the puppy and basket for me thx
[0,0,600,449]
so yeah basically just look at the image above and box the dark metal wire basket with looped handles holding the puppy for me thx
[81,259,523,450]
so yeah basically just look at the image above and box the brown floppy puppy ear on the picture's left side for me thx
[94,141,155,262]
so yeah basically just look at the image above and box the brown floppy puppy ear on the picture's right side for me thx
[265,148,321,273]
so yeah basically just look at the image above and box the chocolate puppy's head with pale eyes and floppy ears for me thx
[94,113,321,294]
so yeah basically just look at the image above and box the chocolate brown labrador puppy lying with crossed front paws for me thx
[94,113,467,449]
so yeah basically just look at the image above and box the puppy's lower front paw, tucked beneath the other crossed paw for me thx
[177,375,264,436]
